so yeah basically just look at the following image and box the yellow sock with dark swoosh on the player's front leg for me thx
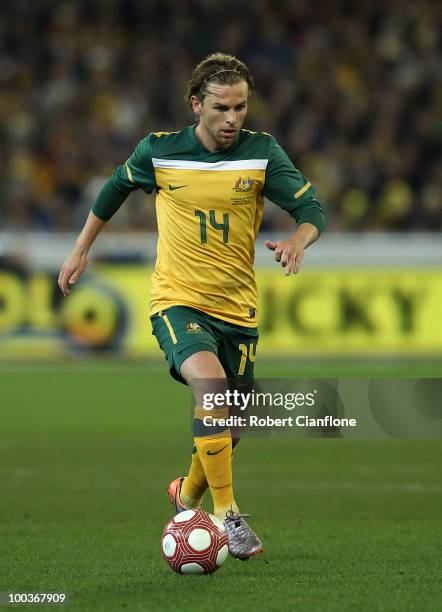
[195,429,238,520]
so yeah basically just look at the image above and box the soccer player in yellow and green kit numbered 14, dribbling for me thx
[59,53,324,559]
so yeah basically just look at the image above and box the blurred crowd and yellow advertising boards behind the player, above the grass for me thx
[0,1,442,358]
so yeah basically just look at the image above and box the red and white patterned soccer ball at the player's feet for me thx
[161,510,229,574]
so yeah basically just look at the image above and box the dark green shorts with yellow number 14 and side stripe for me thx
[150,306,258,384]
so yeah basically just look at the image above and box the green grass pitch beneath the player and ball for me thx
[0,361,442,612]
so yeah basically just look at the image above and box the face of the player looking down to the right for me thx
[192,81,249,151]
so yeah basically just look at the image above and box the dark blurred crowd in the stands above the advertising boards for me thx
[0,0,442,231]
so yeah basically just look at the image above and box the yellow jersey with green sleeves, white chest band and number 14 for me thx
[93,126,324,327]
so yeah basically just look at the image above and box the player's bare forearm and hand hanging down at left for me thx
[58,211,106,297]
